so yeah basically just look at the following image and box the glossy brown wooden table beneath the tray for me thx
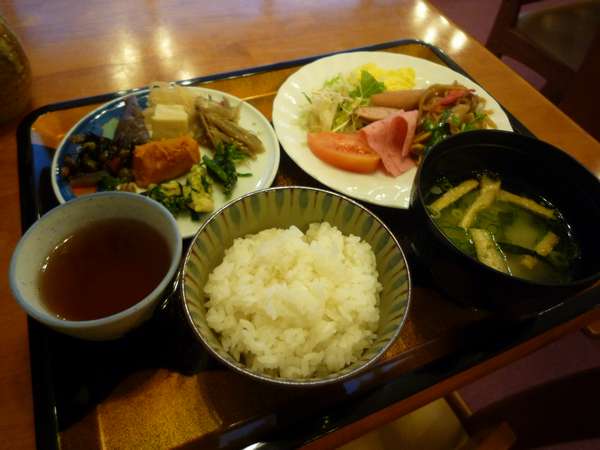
[0,0,600,449]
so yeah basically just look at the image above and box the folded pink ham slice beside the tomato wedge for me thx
[360,110,419,177]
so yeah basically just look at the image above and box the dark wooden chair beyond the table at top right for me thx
[486,0,600,140]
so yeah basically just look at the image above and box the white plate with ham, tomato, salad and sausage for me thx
[273,52,512,209]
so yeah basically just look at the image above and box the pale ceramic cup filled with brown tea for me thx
[9,192,182,340]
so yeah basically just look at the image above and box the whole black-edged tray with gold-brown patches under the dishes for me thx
[18,40,594,450]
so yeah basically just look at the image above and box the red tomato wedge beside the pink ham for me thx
[308,131,380,173]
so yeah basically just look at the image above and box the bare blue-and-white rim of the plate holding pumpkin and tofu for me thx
[51,87,279,238]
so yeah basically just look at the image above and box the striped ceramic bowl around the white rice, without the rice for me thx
[182,187,411,386]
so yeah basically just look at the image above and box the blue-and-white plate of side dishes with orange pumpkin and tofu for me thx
[51,83,279,238]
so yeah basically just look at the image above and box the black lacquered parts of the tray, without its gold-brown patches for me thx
[17,40,598,449]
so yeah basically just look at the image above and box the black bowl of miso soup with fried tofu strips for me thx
[410,130,600,317]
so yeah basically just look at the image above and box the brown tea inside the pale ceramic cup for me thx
[39,219,171,320]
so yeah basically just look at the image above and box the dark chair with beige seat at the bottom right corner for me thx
[338,367,600,450]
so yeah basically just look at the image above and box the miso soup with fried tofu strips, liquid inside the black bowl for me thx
[426,174,580,283]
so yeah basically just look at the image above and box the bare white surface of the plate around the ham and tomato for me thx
[273,52,512,208]
